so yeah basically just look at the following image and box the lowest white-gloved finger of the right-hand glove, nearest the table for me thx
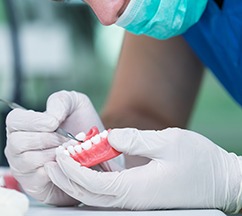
[45,162,115,207]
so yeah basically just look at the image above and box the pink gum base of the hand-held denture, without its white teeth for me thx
[71,127,121,167]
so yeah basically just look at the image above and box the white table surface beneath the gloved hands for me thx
[26,205,228,216]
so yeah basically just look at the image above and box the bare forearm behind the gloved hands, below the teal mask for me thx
[102,33,203,167]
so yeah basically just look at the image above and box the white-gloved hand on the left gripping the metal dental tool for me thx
[5,91,119,205]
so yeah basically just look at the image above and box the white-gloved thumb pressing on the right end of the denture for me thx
[108,128,179,158]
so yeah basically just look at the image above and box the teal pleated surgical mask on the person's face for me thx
[116,0,208,40]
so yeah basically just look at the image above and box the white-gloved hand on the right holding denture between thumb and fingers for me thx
[46,128,242,212]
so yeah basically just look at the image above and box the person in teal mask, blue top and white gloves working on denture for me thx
[5,0,242,213]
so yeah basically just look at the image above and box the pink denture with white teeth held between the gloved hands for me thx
[56,127,121,167]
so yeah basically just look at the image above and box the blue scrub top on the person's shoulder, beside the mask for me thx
[184,0,242,106]
